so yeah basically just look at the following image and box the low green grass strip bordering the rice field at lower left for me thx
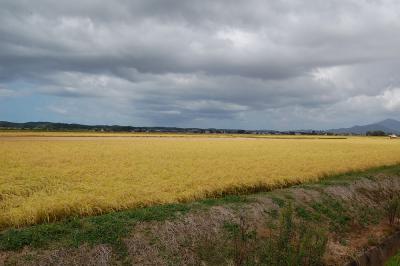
[0,204,190,254]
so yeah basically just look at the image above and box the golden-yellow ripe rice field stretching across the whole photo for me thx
[0,135,400,229]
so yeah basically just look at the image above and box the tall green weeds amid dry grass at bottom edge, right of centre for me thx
[198,203,327,266]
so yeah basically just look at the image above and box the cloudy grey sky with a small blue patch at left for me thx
[0,0,400,130]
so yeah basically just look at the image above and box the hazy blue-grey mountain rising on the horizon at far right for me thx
[327,119,400,135]
